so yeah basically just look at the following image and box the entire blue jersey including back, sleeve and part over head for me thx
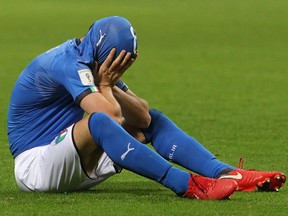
[8,16,138,157]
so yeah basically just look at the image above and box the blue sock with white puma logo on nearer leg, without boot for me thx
[89,113,190,195]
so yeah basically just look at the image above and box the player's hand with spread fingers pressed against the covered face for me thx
[94,48,136,87]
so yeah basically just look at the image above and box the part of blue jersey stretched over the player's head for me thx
[78,16,138,65]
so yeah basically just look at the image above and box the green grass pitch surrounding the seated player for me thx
[0,0,288,216]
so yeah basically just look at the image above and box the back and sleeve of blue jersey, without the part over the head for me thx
[8,39,97,157]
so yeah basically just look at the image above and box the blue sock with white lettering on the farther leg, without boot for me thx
[143,109,235,178]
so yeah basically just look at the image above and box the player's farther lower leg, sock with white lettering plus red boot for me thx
[143,110,286,191]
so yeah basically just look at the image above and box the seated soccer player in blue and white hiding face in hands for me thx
[8,16,286,200]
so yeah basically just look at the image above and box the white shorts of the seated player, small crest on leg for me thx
[15,125,121,192]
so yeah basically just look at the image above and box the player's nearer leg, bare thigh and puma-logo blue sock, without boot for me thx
[74,113,190,194]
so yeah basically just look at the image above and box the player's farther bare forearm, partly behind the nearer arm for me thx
[113,86,151,128]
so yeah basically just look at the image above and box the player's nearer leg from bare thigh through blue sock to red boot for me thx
[73,113,236,199]
